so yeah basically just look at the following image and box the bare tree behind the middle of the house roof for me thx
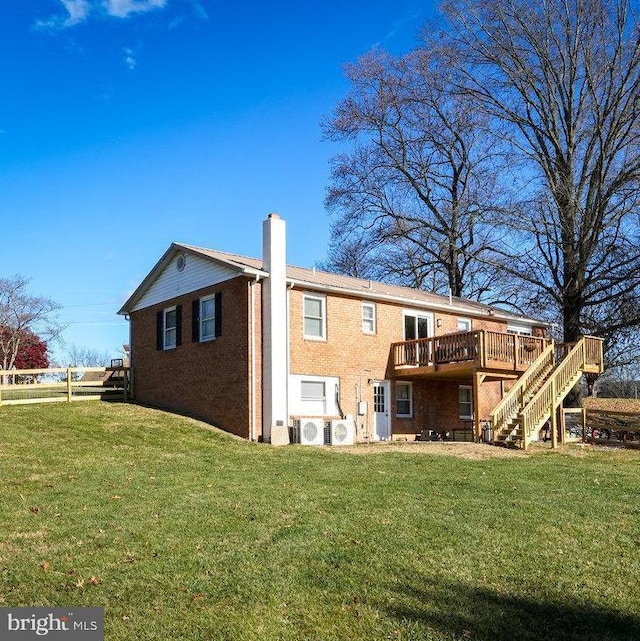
[325,42,508,298]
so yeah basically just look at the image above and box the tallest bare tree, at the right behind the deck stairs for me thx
[445,0,640,341]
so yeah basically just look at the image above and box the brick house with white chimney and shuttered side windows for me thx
[119,214,604,444]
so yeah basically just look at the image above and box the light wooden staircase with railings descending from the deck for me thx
[491,336,603,450]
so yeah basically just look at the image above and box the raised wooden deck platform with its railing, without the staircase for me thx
[391,329,550,379]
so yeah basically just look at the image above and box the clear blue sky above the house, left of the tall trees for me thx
[0,0,433,363]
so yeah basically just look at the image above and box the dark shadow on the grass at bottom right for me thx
[386,577,640,641]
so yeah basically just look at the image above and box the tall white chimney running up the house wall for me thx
[262,214,289,445]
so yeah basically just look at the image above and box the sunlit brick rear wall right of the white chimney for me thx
[290,289,506,438]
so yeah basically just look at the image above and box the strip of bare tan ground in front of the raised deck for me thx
[331,441,528,460]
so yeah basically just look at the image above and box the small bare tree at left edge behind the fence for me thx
[0,275,64,370]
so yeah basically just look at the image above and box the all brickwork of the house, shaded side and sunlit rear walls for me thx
[131,278,544,438]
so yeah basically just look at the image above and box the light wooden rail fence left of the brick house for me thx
[0,365,131,405]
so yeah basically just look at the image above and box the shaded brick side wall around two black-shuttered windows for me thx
[131,278,254,438]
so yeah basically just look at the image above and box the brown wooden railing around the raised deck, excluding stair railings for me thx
[392,329,549,369]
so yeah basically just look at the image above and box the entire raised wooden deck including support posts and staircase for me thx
[391,330,604,449]
